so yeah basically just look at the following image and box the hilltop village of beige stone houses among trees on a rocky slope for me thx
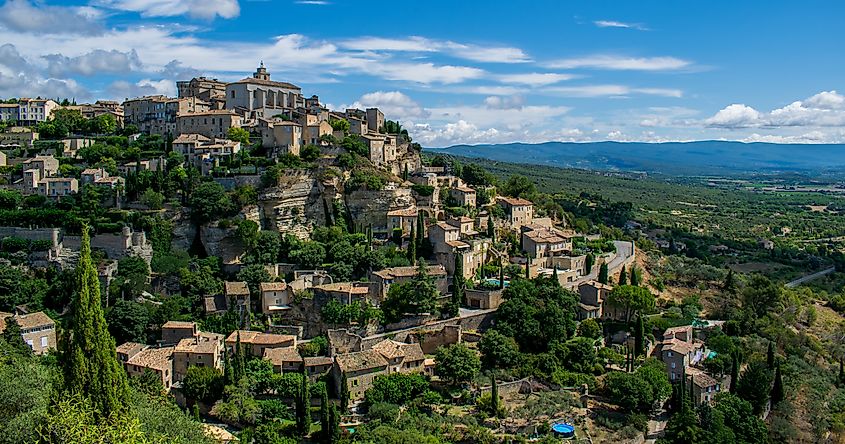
[0,64,767,443]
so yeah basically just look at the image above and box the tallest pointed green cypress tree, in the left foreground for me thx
[59,225,129,418]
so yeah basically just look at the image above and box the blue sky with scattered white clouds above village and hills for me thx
[0,0,845,147]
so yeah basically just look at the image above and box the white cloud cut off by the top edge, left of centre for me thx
[99,0,241,20]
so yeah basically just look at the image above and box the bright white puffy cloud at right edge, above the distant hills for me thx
[704,91,845,129]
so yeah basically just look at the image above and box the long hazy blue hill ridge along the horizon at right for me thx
[426,141,845,175]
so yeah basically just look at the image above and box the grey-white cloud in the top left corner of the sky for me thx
[0,0,103,35]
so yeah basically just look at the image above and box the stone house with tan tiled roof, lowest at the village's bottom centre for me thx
[332,350,388,401]
